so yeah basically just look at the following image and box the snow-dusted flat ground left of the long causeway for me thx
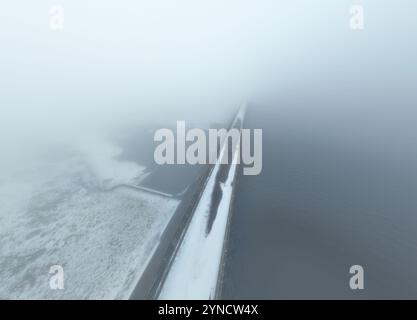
[0,140,178,299]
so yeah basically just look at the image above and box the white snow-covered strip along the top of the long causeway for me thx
[159,106,245,300]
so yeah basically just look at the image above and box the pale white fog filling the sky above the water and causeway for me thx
[0,0,417,165]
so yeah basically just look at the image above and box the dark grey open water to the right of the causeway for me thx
[222,99,417,299]
